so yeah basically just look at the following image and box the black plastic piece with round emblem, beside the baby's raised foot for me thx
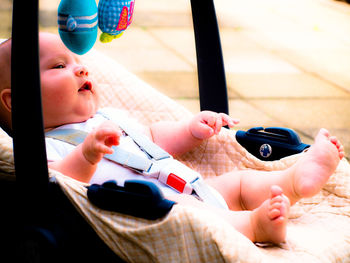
[236,127,310,161]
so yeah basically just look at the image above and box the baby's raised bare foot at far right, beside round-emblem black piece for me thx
[289,129,344,203]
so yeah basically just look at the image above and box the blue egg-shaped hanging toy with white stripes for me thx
[58,0,98,55]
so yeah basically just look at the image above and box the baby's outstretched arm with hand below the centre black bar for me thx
[150,111,239,156]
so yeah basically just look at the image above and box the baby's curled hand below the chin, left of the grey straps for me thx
[82,121,122,164]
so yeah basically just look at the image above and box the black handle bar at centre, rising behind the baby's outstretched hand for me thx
[191,0,229,114]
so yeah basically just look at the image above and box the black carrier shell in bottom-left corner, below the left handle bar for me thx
[0,183,124,263]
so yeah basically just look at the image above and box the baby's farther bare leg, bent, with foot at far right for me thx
[207,129,344,210]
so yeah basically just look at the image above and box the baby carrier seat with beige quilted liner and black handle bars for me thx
[0,0,350,262]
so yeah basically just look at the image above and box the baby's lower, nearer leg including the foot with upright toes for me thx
[168,186,289,244]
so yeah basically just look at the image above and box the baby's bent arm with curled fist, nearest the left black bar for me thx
[49,122,121,183]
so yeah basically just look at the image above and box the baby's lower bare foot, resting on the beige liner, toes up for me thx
[251,185,290,244]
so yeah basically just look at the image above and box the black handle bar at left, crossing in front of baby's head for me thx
[11,0,48,210]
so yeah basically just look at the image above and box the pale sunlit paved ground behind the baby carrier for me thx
[0,0,350,157]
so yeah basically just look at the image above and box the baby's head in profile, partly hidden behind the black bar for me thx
[0,33,98,132]
